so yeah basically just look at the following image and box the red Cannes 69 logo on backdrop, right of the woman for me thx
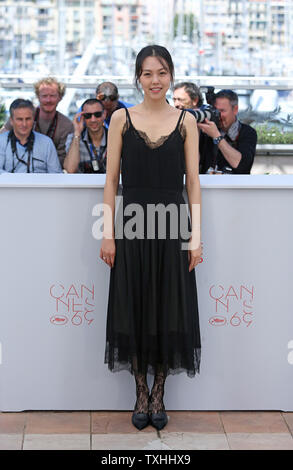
[209,284,254,327]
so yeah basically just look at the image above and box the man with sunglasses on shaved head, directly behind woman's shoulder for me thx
[96,82,133,128]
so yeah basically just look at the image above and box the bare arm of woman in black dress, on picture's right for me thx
[184,112,201,271]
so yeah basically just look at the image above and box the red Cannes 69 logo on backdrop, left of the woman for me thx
[50,283,95,326]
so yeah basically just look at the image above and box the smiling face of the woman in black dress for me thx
[139,56,171,99]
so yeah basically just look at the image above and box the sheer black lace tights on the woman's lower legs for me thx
[134,372,166,413]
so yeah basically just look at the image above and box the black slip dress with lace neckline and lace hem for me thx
[104,109,201,377]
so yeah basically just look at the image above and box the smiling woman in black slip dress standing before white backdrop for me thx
[100,45,201,429]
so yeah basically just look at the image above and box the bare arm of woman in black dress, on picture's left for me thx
[100,109,125,267]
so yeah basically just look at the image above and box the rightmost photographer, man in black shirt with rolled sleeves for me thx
[198,90,257,174]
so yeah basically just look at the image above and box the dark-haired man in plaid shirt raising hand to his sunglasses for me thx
[63,98,107,173]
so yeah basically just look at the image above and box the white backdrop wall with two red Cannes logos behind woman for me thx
[0,175,293,411]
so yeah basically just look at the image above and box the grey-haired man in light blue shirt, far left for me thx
[0,99,62,173]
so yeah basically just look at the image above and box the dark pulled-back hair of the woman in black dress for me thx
[135,44,174,89]
